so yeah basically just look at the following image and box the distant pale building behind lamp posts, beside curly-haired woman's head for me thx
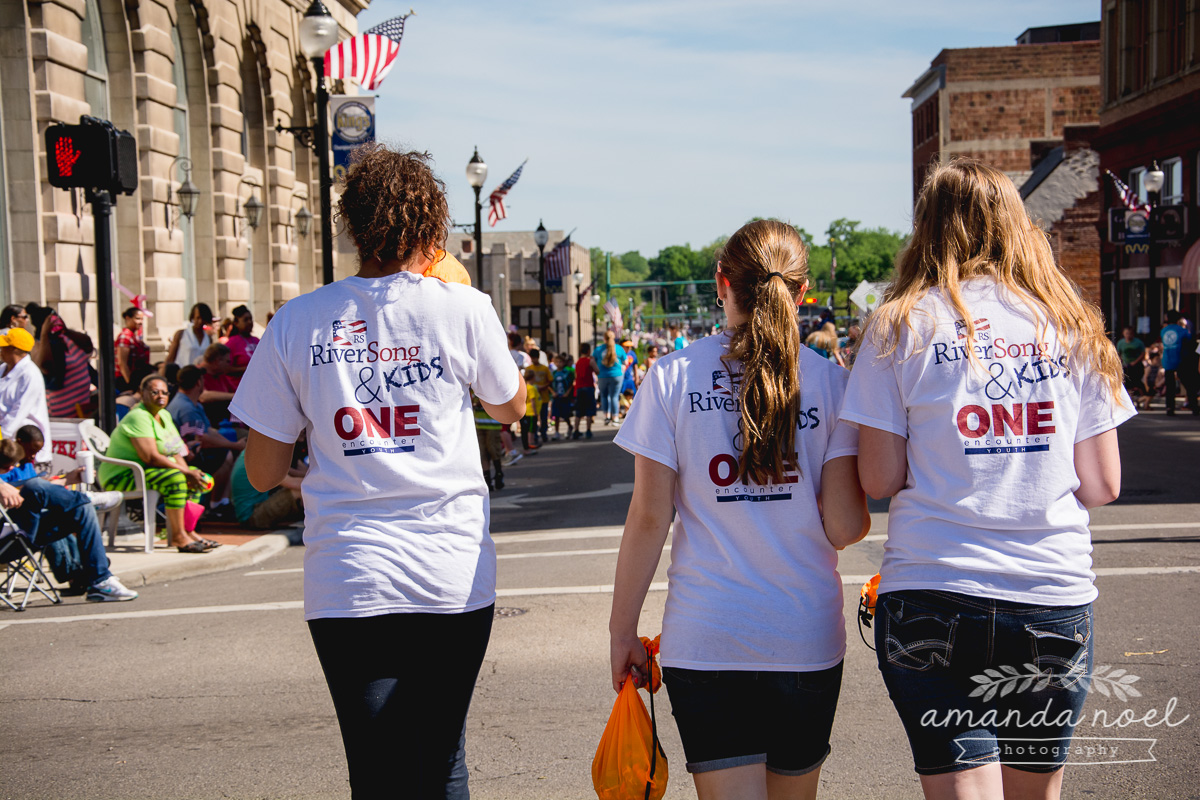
[446,230,595,354]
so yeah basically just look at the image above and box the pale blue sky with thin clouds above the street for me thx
[359,0,1100,257]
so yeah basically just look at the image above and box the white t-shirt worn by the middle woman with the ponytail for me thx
[616,333,858,672]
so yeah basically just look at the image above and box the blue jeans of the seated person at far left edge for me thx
[8,477,113,585]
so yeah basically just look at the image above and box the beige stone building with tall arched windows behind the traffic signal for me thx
[0,0,368,353]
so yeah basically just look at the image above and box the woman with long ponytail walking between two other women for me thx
[608,221,870,799]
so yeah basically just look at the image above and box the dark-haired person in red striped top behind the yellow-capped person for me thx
[25,303,96,417]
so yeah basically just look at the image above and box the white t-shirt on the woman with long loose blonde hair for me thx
[842,281,1134,606]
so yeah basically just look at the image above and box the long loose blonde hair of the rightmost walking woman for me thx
[869,158,1122,397]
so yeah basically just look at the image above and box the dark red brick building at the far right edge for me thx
[1092,0,1200,338]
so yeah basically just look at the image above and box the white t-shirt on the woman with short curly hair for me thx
[230,272,520,619]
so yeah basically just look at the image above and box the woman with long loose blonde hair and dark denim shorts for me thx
[844,160,1134,799]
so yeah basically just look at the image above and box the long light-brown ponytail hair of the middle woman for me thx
[716,219,809,485]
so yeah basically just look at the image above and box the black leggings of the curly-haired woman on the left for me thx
[308,606,494,800]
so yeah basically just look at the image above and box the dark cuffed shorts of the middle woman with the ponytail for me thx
[662,663,841,775]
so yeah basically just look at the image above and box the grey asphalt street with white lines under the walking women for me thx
[0,411,1200,800]
